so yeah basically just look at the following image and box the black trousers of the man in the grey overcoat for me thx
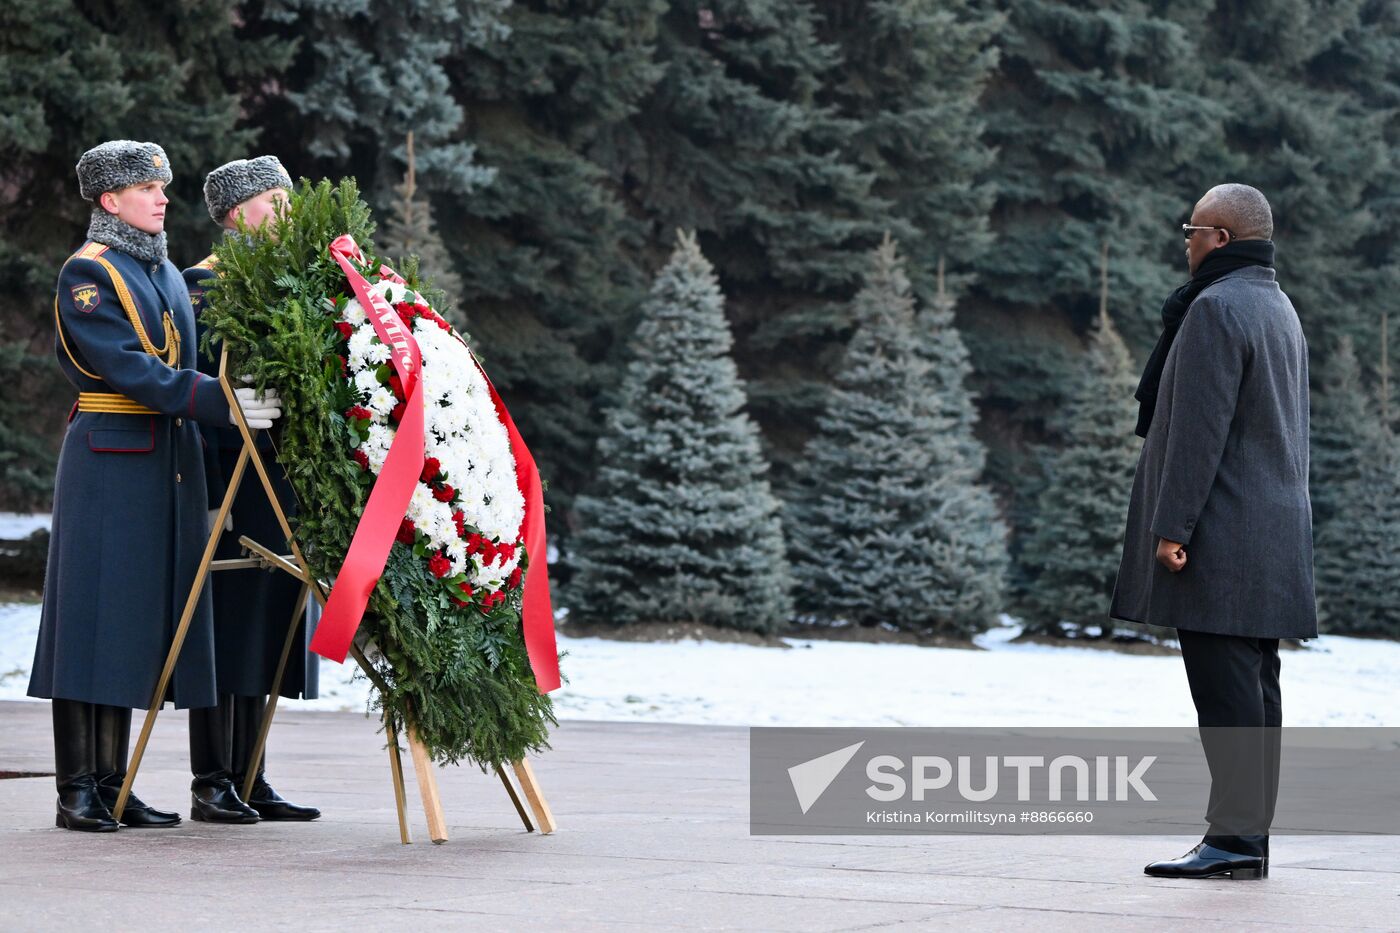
[1177,629,1284,855]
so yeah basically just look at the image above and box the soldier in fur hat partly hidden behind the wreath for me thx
[185,156,321,822]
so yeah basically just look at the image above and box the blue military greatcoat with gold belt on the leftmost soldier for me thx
[29,241,228,709]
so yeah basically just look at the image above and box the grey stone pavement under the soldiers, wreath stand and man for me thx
[0,703,1400,932]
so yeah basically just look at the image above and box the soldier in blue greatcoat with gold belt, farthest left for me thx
[29,140,281,832]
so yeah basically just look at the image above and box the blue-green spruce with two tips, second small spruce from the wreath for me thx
[787,237,1007,635]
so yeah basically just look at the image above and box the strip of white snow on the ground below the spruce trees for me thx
[0,604,1400,726]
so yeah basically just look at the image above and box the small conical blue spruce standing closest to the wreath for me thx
[570,233,791,632]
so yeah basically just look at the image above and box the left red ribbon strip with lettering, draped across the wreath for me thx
[311,235,423,663]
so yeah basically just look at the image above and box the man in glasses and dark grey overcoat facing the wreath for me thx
[1110,185,1317,878]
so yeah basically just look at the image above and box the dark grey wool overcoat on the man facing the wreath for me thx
[1109,266,1317,639]
